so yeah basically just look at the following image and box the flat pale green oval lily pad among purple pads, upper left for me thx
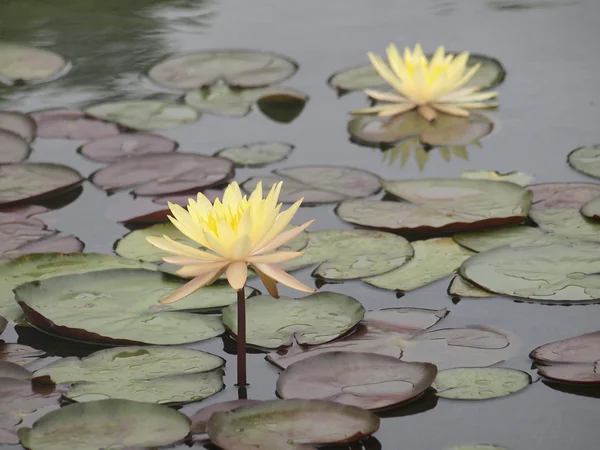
[85,100,200,131]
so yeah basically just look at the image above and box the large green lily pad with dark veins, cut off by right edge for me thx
[460,242,600,302]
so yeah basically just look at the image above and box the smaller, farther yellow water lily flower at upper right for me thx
[352,44,498,121]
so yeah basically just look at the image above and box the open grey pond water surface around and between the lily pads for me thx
[0,0,600,450]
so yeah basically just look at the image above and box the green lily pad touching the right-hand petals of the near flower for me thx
[280,230,413,281]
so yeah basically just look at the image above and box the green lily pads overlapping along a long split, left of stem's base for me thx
[32,346,225,404]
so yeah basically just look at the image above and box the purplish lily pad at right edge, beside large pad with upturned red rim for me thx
[527,183,600,209]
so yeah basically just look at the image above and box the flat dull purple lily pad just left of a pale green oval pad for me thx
[31,109,120,140]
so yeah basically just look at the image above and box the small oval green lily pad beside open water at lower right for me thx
[433,367,531,400]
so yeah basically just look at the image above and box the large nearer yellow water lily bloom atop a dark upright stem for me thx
[146,182,315,304]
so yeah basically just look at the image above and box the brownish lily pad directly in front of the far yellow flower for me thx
[348,111,494,147]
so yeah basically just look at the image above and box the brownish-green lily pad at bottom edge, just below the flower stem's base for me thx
[207,399,379,450]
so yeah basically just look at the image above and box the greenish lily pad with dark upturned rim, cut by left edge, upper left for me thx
[0,163,83,206]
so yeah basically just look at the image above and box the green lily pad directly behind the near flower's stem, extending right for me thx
[222,292,365,349]
